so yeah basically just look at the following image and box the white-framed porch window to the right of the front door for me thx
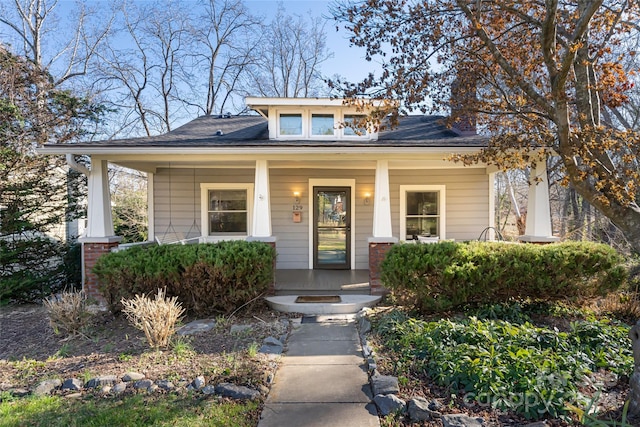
[400,185,445,240]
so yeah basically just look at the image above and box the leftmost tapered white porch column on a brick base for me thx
[86,158,115,238]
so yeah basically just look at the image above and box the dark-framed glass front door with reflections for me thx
[313,187,351,270]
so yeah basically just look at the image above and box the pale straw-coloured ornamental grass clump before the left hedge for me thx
[121,289,184,349]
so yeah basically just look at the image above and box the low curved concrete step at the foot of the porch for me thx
[265,292,382,314]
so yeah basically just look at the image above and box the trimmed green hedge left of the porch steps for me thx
[93,241,276,315]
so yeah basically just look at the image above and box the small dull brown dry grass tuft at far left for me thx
[43,291,92,335]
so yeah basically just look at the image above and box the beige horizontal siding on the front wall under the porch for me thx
[153,168,489,269]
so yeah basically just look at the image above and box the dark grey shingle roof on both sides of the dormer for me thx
[46,116,487,151]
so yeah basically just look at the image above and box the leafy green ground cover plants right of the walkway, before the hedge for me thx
[374,302,633,425]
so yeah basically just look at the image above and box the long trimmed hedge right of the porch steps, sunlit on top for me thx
[381,242,626,312]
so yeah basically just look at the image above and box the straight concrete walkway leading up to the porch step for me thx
[258,315,380,427]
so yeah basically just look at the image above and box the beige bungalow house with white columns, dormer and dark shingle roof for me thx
[40,98,551,302]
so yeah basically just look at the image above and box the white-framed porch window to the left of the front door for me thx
[201,184,253,236]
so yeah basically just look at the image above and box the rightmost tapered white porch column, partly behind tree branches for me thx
[519,160,559,243]
